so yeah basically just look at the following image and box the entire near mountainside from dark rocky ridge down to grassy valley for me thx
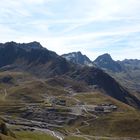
[0,42,140,140]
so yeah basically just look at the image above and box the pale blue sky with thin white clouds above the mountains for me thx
[0,0,140,60]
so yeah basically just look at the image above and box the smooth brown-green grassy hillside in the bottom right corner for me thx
[80,111,140,137]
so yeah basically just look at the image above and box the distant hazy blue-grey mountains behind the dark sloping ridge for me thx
[62,52,140,96]
